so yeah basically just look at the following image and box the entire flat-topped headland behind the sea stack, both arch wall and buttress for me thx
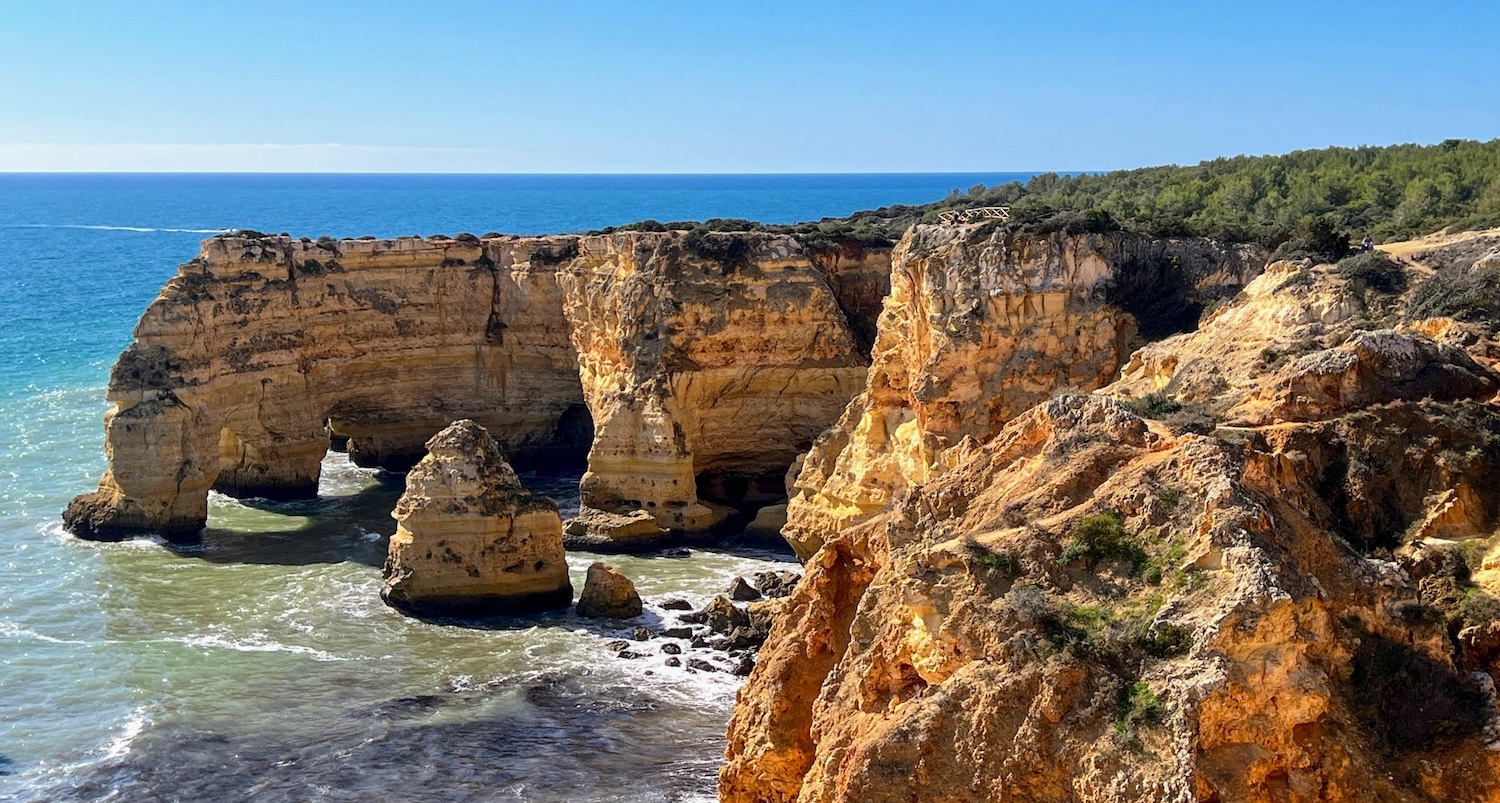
[65,233,885,546]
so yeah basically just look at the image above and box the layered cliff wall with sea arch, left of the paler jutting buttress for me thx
[65,237,587,537]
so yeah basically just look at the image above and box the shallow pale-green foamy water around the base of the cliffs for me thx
[0,455,788,800]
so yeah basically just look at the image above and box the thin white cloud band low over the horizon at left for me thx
[0,143,521,173]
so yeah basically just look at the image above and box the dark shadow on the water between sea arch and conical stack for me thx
[167,477,402,567]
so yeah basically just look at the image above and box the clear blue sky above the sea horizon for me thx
[0,0,1500,173]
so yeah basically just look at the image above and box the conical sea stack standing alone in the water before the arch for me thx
[381,420,573,615]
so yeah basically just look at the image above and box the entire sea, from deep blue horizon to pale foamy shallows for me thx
[0,174,1025,801]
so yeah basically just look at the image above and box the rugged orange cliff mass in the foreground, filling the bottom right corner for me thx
[720,255,1500,803]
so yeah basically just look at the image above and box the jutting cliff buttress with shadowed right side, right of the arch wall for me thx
[558,233,867,548]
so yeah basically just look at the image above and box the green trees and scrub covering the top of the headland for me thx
[603,140,1500,251]
